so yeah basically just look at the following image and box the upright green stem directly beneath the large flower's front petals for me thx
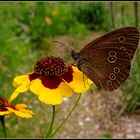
[46,105,55,138]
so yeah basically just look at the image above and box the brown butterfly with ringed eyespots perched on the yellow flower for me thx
[71,27,140,91]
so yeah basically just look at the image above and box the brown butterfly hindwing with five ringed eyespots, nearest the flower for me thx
[79,48,131,91]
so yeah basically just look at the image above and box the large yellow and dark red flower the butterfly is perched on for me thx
[13,56,92,105]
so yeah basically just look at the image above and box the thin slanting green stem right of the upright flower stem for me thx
[50,94,81,138]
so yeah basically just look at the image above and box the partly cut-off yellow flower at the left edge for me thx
[0,91,33,118]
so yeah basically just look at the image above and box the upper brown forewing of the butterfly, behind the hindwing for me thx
[80,27,140,59]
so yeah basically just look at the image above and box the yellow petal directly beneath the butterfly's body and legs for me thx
[65,66,93,93]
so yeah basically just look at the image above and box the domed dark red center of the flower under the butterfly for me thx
[34,56,68,77]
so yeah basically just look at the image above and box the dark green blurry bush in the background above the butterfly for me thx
[72,2,106,30]
